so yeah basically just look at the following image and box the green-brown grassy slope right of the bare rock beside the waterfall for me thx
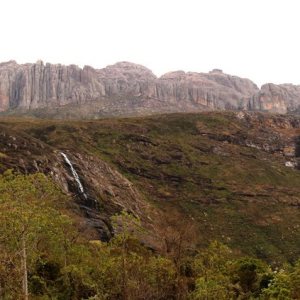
[3,113,300,262]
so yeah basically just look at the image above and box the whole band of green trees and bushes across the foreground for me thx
[0,171,300,300]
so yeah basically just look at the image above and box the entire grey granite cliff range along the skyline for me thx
[0,61,300,117]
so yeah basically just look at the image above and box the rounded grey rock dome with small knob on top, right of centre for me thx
[156,70,258,110]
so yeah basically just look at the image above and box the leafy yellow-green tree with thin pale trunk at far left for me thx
[0,171,70,299]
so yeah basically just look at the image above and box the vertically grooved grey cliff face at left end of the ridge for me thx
[0,61,103,111]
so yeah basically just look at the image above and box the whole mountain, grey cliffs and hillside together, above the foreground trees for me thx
[0,61,300,263]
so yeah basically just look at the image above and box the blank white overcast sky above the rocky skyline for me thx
[0,0,300,85]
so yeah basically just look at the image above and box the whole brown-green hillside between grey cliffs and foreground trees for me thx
[0,113,300,263]
